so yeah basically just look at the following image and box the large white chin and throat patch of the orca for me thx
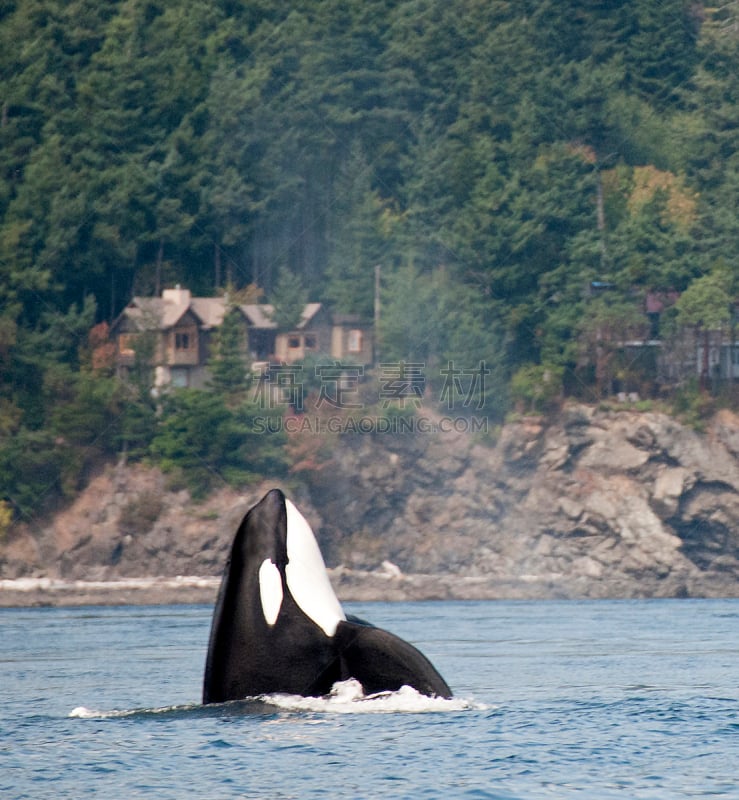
[285,500,346,636]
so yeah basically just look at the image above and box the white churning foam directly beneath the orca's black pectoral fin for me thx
[260,678,488,714]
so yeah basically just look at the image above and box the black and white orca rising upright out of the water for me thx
[203,489,452,705]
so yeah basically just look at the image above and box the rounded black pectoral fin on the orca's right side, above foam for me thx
[334,621,452,697]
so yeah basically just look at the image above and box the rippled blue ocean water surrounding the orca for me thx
[0,600,739,800]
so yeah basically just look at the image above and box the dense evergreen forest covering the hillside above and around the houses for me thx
[0,0,739,528]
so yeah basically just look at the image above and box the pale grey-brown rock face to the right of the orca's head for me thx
[310,406,739,597]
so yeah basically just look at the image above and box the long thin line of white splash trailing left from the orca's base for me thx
[69,678,489,719]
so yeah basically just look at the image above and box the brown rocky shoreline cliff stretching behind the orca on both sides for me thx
[0,405,739,599]
